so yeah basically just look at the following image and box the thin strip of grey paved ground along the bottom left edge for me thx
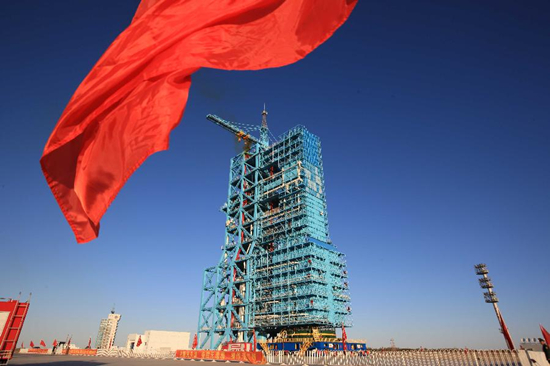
[8,353,220,366]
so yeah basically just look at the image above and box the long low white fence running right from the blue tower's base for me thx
[267,350,529,366]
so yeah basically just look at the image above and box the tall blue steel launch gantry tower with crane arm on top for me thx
[201,107,351,351]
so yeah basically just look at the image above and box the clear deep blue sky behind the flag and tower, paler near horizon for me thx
[0,0,550,348]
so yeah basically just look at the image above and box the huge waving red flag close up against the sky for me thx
[40,0,357,243]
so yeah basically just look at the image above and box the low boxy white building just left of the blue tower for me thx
[126,330,190,353]
